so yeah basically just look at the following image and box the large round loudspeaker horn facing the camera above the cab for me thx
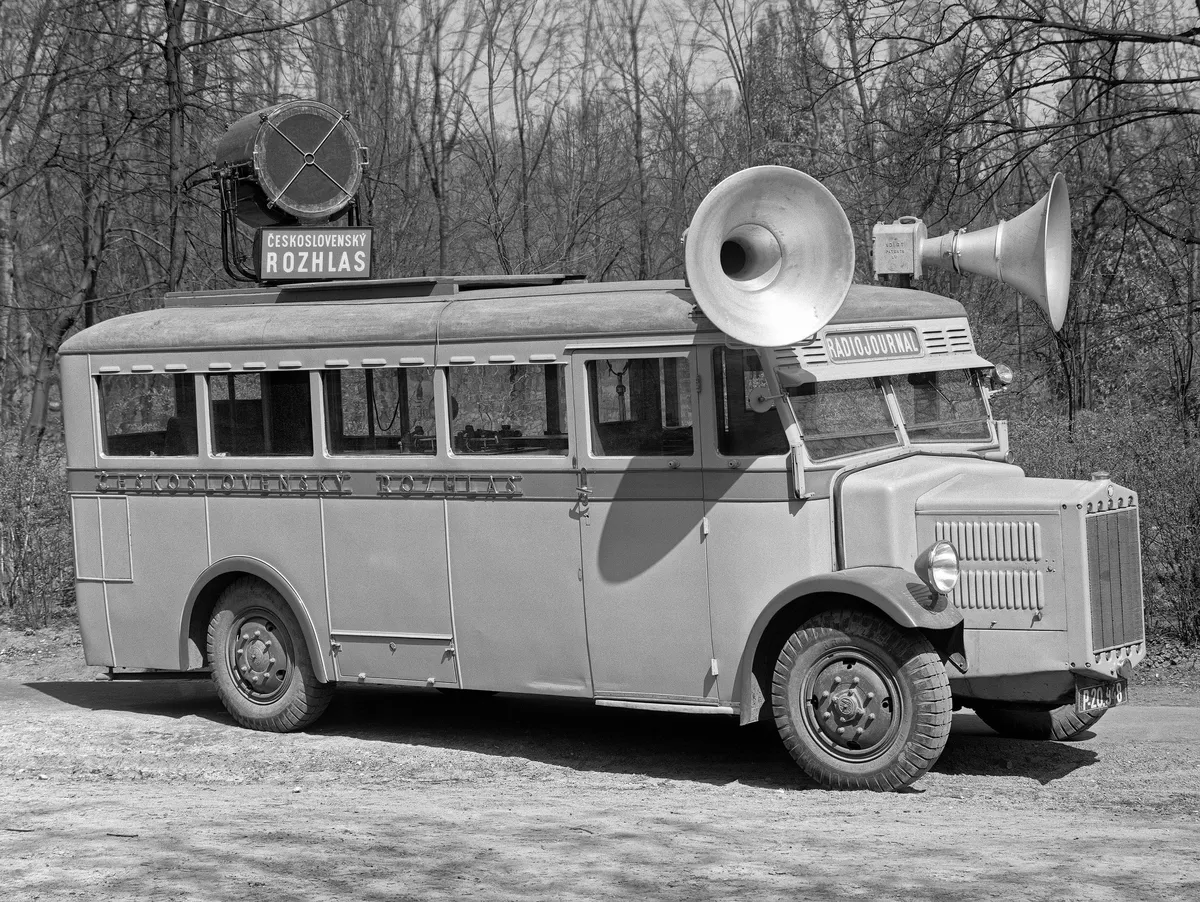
[685,166,854,347]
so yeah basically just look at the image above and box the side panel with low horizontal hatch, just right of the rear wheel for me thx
[322,498,458,686]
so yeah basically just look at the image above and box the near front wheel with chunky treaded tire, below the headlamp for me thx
[772,611,952,792]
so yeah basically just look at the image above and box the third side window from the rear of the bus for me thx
[322,367,438,455]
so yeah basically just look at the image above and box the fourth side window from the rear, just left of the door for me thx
[449,363,566,457]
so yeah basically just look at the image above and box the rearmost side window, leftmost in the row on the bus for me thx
[100,373,198,457]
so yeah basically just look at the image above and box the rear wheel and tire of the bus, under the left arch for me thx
[209,577,334,733]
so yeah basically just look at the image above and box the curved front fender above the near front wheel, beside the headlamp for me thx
[734,567,962,723]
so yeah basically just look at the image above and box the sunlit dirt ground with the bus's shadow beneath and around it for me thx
[0,624,1200,902]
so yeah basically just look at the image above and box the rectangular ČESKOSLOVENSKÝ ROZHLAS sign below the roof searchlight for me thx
[254,228,373,282]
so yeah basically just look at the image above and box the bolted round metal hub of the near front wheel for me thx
[800,648,902,763]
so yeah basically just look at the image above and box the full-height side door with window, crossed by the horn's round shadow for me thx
[572,350,716,704]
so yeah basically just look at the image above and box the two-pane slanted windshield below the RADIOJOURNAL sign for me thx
[787,369,991,461]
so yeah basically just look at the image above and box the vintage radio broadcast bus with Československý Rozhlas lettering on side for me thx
[60,161,1145,789]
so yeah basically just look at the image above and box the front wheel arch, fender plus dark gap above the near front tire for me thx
[733,567,962,724]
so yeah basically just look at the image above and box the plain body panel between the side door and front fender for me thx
[706,486,833,704]
